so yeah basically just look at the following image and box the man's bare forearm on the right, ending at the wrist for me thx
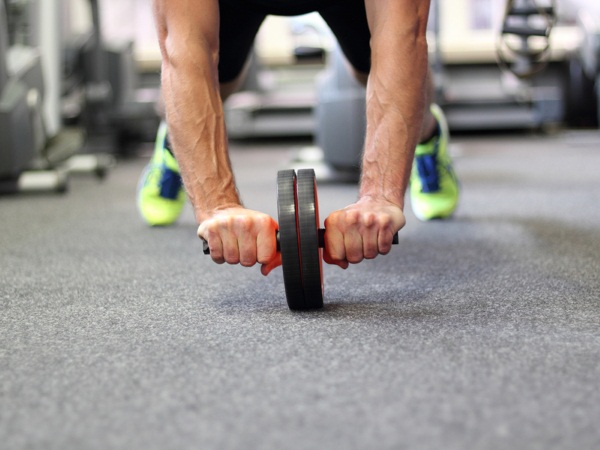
[360,1,429,208]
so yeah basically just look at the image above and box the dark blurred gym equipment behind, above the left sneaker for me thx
[62,0,160,154]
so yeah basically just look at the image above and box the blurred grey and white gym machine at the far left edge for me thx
[0,0,111,193]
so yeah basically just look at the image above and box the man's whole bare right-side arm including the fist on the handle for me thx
[325,0,429,267]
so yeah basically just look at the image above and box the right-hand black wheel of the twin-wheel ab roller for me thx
[297,169,323,309]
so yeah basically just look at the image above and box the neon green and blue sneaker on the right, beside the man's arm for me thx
[410,105,458,221]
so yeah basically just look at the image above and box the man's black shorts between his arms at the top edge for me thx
[219,0,371,82]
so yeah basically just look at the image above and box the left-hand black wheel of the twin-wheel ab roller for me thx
[277,170,306,310]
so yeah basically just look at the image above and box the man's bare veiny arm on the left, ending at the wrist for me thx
[154,0,240,223]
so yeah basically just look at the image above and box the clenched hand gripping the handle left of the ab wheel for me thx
[198,207,281,275]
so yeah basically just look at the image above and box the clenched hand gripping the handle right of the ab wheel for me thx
[323,197,406,269]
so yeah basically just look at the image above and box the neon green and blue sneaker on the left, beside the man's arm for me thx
[137,121,186,226]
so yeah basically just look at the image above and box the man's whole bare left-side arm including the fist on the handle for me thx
[154,0,280,268]
